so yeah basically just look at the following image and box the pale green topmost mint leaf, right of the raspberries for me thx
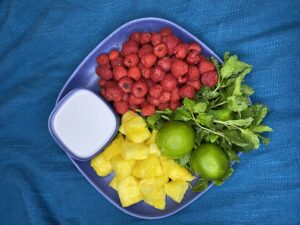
[221,55,251,79]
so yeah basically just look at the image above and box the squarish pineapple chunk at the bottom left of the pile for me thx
[117,176,143,207]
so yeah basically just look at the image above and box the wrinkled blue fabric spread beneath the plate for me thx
[0,0,300,225]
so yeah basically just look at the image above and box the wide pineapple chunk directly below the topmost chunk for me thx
[121,140,149,160]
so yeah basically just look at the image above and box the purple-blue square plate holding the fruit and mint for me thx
[51,17,232,219]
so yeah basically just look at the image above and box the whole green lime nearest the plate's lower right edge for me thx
[191,143,230,180]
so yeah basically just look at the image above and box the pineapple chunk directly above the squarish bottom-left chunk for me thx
[111,156,135,179]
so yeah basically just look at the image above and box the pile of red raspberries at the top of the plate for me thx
[96,28,218,116]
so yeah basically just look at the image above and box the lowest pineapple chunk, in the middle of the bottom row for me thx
[140,177,166,209]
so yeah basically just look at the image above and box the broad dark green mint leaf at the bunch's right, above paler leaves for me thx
[242,104,269,126]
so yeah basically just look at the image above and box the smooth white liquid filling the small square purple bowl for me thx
[53,89,117,159]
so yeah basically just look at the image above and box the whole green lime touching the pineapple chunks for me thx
[155,121,195,159]
